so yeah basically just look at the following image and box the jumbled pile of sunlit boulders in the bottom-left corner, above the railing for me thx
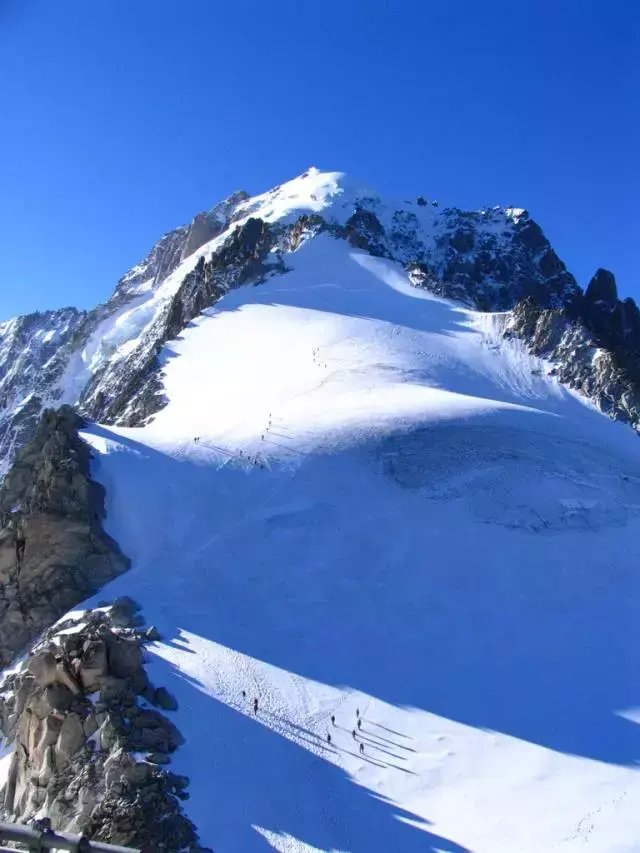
[0,599,210,853]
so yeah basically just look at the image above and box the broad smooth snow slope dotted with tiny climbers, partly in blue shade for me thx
[86,235,640,853]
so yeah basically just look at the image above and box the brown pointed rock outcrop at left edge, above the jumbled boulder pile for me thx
[0,407,128,666]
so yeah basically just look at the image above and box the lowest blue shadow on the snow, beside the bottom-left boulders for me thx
[161,666,470,853]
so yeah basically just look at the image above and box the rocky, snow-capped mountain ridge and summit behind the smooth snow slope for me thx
[0,169,640,480]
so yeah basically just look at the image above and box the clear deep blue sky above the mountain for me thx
[0,0,640,319]
